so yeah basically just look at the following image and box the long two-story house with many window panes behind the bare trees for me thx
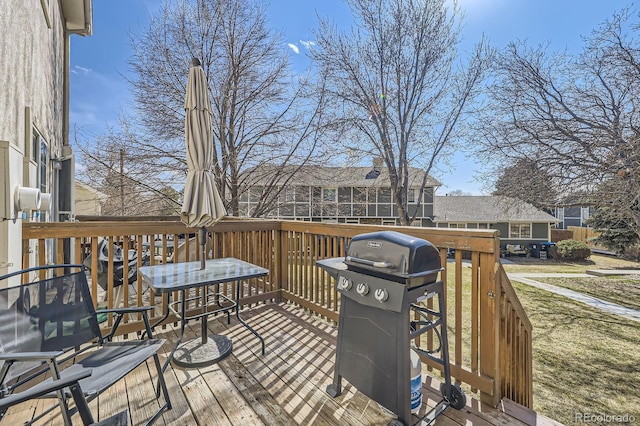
[239,162,440,226]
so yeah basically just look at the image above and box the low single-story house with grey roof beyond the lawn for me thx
[433,195,558,247]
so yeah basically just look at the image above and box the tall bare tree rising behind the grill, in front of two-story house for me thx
[311,0,490,225]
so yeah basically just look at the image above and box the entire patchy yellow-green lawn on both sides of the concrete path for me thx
[505,256,640,424]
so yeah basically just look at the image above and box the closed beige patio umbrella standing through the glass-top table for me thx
[180,58,226,269]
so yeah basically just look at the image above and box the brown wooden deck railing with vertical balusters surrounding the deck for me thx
[23,218,532,407]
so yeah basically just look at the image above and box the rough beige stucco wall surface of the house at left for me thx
[0,0,65,159]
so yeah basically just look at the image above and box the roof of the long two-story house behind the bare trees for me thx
[246,166,441,188]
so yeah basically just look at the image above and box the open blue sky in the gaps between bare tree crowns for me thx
[70,0,631,195]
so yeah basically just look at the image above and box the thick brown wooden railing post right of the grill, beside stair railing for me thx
[480,243,501,407]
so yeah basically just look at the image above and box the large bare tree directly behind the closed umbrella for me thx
[77,0,322,215]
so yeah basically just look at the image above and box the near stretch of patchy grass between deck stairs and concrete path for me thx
[513,282,640,424]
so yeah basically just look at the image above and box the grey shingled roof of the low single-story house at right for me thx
[433,195,559,223]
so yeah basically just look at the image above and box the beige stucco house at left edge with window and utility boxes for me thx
[0,0,92,274]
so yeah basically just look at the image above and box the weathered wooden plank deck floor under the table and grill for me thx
[2,303,555,426]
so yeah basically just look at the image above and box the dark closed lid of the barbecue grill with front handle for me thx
[345,231,442,281]
